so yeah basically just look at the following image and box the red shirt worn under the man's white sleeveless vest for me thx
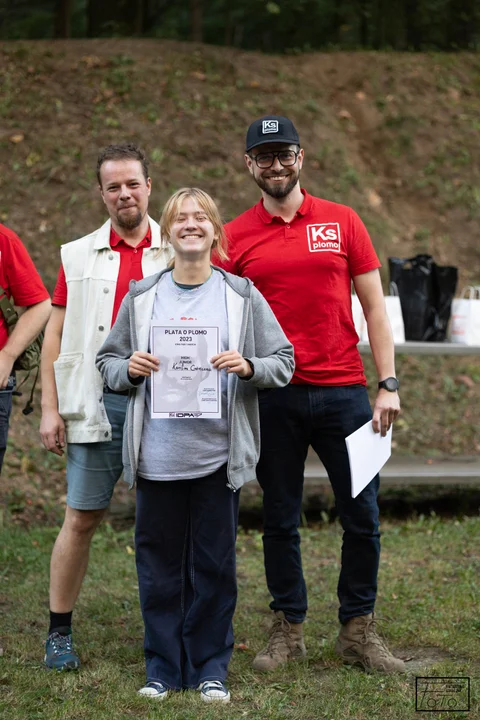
[52,226,152,325]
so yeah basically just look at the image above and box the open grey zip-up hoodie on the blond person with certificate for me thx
[96,268,294,490]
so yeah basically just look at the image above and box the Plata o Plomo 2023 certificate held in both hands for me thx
[150,324,222,419]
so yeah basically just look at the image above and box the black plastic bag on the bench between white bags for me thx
[388,255,458,342]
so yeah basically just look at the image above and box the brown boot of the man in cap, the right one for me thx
[335,613,406,673]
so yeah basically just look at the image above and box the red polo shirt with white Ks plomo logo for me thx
[222,190,380,385]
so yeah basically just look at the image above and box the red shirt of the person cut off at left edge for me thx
[0,225,50,349]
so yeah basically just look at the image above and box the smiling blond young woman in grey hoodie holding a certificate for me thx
[97,188,294,702]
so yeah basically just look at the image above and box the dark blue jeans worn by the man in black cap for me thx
[257,385,380,623]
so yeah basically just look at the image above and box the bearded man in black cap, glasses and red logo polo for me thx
[218,116,405,672]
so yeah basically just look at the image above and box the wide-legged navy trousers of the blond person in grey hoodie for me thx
[135,466,239,690]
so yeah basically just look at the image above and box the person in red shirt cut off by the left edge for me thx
[0,225,51,472]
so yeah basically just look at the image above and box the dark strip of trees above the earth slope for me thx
[0,0,480,53]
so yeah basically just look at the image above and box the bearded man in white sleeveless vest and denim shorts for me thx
[40,144,170,670]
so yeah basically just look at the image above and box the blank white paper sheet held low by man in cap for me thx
[345,420,392,497]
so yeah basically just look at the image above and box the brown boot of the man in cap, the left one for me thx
[253,610,307,672]
